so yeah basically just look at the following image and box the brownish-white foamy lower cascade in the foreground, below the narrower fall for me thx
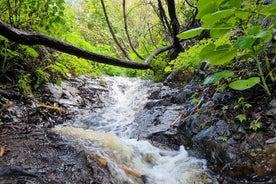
[55,126,206,184]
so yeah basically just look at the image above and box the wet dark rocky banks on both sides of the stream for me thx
[0,77,276,184]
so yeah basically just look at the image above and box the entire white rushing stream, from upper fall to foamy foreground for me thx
[55,77,209,184]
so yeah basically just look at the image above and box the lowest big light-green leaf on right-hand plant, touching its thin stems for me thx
[229,77,260,91]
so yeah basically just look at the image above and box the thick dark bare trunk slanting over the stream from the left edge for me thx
[0,20,150,69]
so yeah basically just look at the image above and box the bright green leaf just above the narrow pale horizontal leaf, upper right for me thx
[201,9,235,28]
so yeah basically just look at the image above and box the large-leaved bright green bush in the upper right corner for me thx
[178,0,276,95]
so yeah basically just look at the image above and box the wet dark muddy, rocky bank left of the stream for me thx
[0,78,114,184]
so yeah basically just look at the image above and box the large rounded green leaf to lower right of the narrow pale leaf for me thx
[200,43,237,65]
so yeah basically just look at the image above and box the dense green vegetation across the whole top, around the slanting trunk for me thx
[0,0,276,98]
